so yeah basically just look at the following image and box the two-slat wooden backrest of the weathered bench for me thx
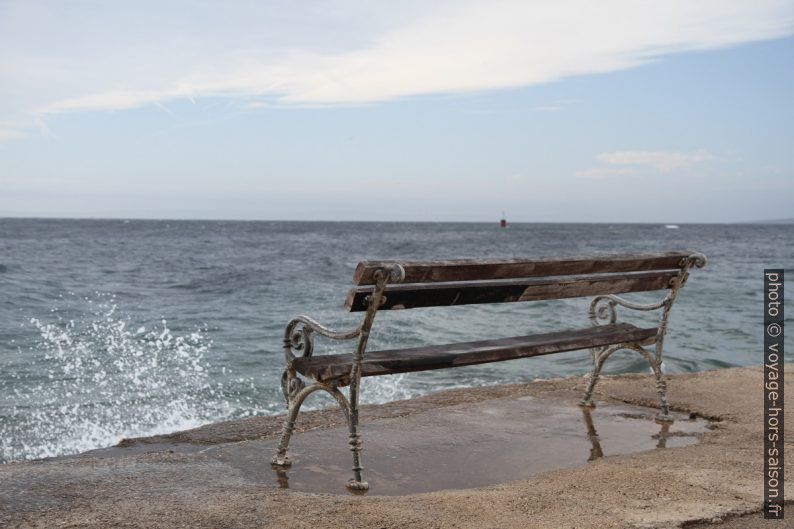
[345,251,692,312]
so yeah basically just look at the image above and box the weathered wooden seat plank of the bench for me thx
[293,323,657,384]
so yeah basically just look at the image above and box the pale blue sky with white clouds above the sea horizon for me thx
[0,0,794,223]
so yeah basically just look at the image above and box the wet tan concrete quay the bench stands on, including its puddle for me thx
[0,364,794,529]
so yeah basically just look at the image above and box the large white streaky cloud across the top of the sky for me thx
[0,0,794,140]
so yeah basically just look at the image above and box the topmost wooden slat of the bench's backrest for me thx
[353,251,692,285]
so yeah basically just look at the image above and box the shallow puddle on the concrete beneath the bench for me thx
[209,397,710,495]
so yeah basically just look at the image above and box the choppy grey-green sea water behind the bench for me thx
[0,219,794,462]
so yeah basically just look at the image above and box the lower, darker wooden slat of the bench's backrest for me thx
[345,270,679,312]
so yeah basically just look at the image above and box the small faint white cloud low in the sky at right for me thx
[576,149,717,179]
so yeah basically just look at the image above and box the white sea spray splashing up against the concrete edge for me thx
[0,295,256,461]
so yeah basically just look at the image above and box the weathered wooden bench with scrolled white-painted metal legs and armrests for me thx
[272,251,706,490]
